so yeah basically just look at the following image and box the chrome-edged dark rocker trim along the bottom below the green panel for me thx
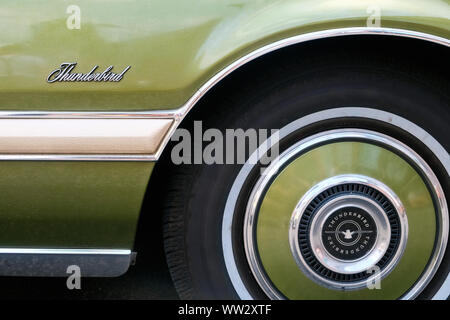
[0,248,131,277]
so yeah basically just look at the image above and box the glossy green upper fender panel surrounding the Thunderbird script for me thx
[0,0,450,111]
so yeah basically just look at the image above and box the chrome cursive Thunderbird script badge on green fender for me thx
[47,62,131,83]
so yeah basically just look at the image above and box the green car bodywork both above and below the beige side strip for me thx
[0,0,450,278]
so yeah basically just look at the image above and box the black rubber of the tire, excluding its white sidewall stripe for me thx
[158,37,450,299]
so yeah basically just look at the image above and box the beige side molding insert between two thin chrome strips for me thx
[0,118,173,159]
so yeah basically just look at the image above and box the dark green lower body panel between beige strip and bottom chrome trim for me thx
[0,161,154,249]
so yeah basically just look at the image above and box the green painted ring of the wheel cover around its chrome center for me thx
[256,142,436,299]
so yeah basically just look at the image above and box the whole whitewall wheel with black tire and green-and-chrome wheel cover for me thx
[165,53,450,299]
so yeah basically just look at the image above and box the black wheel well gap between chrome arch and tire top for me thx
[180,35,450,127]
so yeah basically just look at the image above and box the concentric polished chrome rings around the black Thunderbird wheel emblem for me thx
[289,175,408,290]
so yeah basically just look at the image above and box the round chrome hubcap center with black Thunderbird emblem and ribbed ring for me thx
[289,175,408,290]
